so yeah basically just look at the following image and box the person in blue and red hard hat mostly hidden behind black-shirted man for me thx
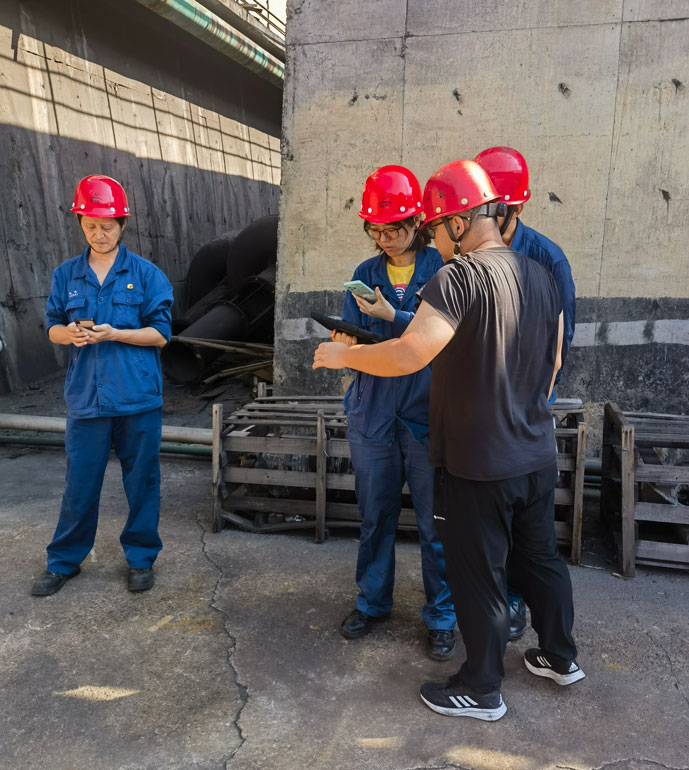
[474,147,576,642]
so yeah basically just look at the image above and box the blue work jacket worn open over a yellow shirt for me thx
[342,247,443,445]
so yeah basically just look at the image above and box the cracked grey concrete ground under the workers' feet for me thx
[0,428,689,770]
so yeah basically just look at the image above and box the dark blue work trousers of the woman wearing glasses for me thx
[350,423,455,630]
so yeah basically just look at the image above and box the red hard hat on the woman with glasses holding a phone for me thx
[359,166,422,224]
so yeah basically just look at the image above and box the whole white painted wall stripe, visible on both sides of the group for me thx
[278,318,689,348]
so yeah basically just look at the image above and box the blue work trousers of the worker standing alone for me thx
[47,409,163,574]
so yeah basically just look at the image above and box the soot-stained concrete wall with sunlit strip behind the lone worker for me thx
[0,0,282,391]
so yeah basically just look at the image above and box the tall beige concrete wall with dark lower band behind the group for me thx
[276,0,689,411]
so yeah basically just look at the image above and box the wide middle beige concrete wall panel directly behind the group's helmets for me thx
[403,25,619,290]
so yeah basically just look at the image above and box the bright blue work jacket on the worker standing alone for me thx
[46,245,172,417]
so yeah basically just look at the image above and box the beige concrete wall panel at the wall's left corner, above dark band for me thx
[279,40,403,291]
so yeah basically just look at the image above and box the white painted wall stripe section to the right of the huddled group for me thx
[572,319,689,348]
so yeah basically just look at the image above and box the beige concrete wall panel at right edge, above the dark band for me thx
[601,20,689,297]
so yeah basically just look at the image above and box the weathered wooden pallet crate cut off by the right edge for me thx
[601,402,689,577]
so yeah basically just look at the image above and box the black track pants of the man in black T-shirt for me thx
[434,465,577,694]
